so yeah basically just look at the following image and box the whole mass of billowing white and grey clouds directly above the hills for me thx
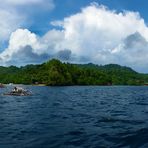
[0,3,148,72]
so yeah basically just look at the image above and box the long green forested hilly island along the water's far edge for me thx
[0,59,148,86]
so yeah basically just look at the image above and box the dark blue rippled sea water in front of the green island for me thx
[0,86,148,148]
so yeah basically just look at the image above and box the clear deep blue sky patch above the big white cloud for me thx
[29,0,148,35]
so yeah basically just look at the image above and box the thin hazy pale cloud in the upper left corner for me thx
[0,0,54,43]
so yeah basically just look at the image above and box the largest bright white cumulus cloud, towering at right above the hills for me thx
[52,4,148,70]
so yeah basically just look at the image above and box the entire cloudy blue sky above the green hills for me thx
[0,0,148,73]
